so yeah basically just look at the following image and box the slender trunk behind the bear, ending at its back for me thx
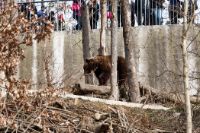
[99,0,107,55]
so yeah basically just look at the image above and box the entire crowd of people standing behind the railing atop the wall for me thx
[19,0,198,30]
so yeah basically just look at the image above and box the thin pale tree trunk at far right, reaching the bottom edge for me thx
[182,0,192,133]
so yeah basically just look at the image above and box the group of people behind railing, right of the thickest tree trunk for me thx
[121,0,198,26]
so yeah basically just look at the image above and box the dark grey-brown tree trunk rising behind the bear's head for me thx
[81,2,94,84]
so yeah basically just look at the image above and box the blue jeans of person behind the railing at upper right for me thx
[153,8,163,25]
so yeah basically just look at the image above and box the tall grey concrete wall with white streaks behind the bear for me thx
[18,25,200,93]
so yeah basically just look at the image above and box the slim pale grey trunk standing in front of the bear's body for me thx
[110,0,119,100]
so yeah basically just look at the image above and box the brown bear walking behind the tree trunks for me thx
[83,55,127,87]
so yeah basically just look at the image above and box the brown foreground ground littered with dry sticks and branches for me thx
[0,92,200,133]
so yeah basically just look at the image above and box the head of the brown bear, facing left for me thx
[83,58,98,74]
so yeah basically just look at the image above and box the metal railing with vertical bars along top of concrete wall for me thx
[14,0,200,31]
